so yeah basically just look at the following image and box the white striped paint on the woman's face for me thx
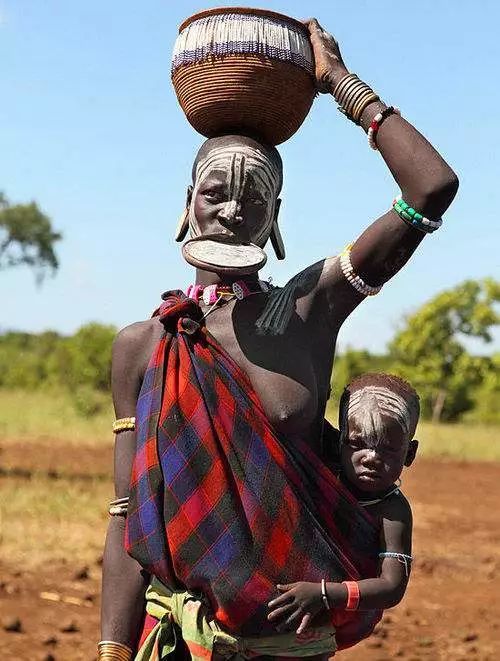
[189,142,281,247]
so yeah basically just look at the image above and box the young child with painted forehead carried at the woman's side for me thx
[268,373,420,634]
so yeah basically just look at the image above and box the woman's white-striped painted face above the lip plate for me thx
[189,142,281,247]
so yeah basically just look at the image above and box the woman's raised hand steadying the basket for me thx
[304,18,349,94]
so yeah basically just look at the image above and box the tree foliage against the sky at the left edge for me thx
[0,193,61,282]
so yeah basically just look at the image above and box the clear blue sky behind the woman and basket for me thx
[0,0,500,350]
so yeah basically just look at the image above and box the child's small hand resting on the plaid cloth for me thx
[267,581,324,634]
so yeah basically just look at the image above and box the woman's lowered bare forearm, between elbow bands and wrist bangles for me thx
[101,517,149,650]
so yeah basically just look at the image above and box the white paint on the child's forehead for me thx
[341,386,417,448]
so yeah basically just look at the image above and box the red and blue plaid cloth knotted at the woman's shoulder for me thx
[126,291,381,648]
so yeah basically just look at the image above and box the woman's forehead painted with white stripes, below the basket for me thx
[195,143,282,196]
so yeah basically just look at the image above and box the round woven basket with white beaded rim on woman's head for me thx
[172,7,315,145]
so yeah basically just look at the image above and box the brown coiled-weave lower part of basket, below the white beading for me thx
[172,54,315,145]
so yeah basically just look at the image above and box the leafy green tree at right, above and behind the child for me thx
[389,278,500,420]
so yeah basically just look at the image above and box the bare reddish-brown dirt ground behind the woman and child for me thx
[0,446,500,661]
